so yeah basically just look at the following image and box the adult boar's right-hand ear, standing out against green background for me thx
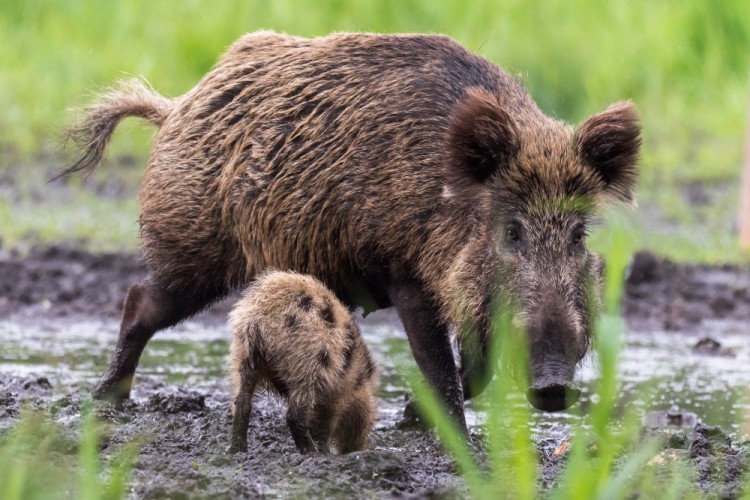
[575,102,641,202]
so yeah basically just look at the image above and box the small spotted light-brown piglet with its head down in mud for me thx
[229,271,377,453]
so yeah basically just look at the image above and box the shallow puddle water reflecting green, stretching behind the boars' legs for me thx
[0,312,750,440]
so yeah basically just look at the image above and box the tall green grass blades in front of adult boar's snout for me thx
[406,316,680,499]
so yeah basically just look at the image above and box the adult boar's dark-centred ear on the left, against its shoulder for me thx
[447,88,519,187]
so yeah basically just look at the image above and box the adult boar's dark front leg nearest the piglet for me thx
[388,282,466,431]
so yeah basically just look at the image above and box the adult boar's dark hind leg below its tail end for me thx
[94,278,226,399]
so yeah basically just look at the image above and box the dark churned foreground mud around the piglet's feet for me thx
[0,372,466,498]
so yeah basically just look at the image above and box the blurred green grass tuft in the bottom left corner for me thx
[0,408,138,500]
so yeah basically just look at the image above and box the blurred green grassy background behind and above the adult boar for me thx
[0,0,750,261]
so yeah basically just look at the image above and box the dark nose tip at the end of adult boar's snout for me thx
[526,361,581,411]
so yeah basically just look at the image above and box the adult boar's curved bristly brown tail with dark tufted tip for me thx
[57,78,177,180]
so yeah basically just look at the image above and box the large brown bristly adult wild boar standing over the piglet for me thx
[67,32,640,430]
